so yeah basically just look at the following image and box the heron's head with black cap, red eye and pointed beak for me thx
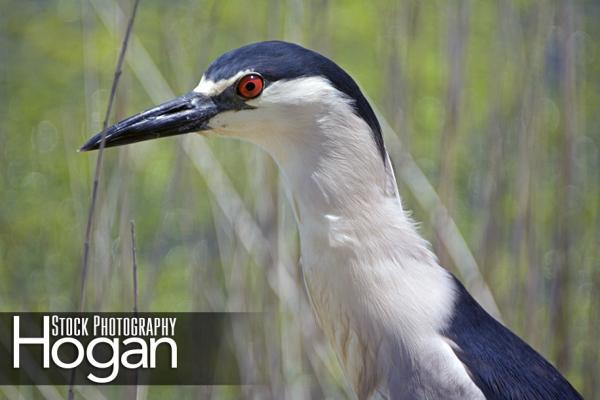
[81,41,384,164]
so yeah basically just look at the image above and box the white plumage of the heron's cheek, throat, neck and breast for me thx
[200,77,484,400]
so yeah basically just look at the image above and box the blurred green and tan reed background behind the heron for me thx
[0,0,600,399]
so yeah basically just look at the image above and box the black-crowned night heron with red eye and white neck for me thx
[81,41,581,400]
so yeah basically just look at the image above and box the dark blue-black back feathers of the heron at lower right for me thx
[443,278,582,400]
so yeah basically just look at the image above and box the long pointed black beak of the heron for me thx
[79,92,219,151]
